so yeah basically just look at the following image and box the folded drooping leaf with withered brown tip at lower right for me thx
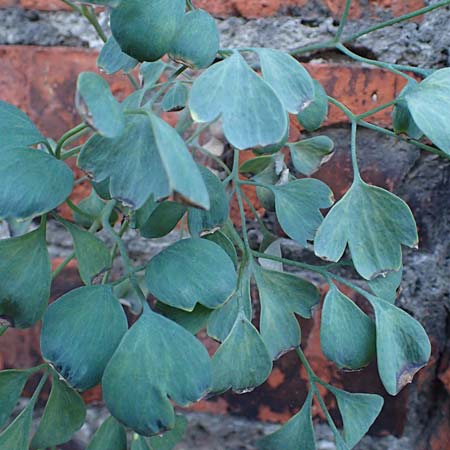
[368,297,431,395]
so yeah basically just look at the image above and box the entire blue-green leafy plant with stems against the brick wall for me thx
[0,0,442,450]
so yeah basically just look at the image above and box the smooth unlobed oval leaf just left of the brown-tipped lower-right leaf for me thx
[320,285,376,370]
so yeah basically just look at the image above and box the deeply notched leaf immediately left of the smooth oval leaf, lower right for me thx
[254,266,320,360]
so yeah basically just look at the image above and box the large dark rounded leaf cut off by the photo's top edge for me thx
[111,0,186,61]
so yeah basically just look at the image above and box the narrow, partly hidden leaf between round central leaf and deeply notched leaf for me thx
[207,263,252,342]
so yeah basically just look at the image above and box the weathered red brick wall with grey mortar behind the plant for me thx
[0,0,450,450]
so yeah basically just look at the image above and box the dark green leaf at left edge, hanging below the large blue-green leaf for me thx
[0,225,51,328]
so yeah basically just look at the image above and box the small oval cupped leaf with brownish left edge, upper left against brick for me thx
[76,72,125,138]
